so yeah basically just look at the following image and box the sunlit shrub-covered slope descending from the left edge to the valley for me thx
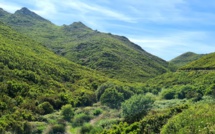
[0,22,111,133]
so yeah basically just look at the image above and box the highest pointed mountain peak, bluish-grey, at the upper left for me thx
[15,7,48,21]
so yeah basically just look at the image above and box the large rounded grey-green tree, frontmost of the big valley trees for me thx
[121,95,154,122]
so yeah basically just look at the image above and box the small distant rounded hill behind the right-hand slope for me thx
[170,52,203,67]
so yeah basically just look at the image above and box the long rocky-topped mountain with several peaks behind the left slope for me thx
[0,8,170,82]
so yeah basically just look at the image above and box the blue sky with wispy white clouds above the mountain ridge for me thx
[0,0,215,61]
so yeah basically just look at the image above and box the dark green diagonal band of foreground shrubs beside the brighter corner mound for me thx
[102,105,188,134]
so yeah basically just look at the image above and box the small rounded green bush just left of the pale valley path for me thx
[61,104,74,121]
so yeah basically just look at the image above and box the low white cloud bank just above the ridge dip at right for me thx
[128,31,215,60]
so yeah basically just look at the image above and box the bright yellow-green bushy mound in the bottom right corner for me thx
[161,103,215,134]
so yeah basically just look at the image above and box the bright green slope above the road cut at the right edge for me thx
[181,53,215,70]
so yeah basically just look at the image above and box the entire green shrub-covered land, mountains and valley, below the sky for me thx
[0,8,215,134]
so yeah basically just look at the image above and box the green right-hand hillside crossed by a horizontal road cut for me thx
[146,53,215,95]
